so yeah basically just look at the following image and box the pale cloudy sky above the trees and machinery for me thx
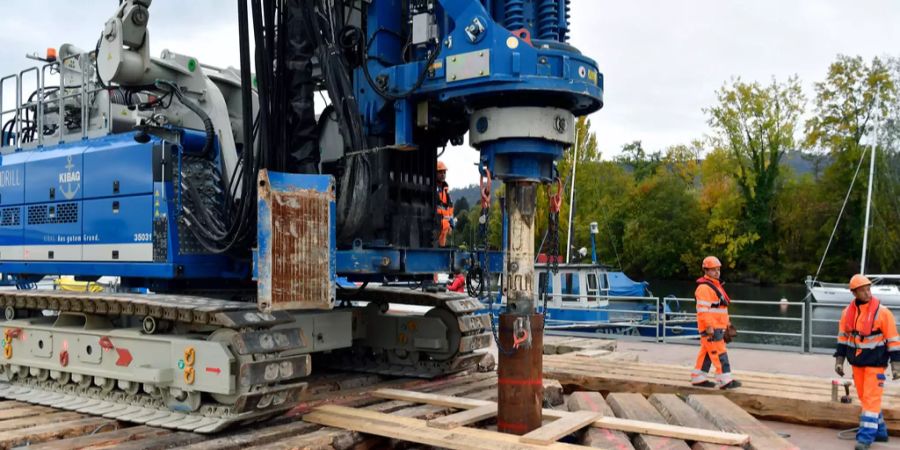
[0,0,900,188]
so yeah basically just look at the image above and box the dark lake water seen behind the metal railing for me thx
[650,280,842,349]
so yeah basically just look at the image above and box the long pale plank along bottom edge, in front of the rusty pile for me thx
[303,405,583,450]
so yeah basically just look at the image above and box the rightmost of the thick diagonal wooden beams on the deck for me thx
[687,395,799,450]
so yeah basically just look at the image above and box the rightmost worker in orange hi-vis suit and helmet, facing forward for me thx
[834,274,900,450]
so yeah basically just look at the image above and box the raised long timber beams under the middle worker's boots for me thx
[544,357,900,432]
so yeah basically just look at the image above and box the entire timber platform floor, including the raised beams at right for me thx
[0,336,884,450]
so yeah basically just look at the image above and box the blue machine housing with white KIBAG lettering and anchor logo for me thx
[0,131,249,279]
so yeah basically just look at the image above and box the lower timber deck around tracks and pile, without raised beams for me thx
[0,366,796,450]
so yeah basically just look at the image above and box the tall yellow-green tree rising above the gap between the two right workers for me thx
[706,77,804,276]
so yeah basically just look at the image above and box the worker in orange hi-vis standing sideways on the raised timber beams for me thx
[691,256,741,389]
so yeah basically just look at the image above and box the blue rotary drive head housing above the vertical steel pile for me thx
[354,0,603,159]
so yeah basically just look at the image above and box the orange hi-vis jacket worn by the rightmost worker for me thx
[834,297,900,367]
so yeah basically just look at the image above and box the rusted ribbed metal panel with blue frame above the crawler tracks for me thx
[256,170,335,311]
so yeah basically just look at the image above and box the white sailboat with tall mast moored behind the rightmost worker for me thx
[805,128,900,306]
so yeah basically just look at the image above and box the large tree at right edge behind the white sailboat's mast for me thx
[806,55,900,280]
